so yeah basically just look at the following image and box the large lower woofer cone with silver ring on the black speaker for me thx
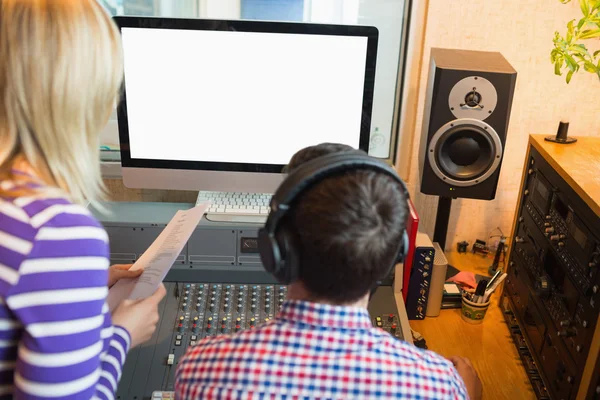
[428,118,502,187]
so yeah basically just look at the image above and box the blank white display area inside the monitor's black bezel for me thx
[122,28,367,164]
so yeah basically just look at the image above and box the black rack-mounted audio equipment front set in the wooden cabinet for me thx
[502,148,600,400]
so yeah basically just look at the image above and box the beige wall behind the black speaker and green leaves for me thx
[400,0,600,249]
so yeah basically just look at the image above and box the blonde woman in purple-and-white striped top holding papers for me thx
[0,0,165,399]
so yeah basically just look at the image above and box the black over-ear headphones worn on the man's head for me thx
[258,150,409,285]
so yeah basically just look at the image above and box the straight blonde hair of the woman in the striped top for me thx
[0,0,123,203]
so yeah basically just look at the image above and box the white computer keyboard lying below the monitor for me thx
[196,191,271,223]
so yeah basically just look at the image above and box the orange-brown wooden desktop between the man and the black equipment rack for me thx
[410,252,536,400]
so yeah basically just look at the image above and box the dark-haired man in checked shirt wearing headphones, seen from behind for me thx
[175,143,481,399]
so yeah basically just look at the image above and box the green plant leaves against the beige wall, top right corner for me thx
[550,0,600,83]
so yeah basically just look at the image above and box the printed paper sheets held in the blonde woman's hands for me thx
[106,203,210,311]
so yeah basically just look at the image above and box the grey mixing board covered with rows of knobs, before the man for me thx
[117,282,403,400]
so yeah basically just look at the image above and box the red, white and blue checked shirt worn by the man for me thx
[175,301,467,399]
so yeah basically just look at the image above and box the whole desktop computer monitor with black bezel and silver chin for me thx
[115,17,378,193]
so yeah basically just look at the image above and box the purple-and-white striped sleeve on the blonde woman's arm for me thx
[6,200,130,399]
